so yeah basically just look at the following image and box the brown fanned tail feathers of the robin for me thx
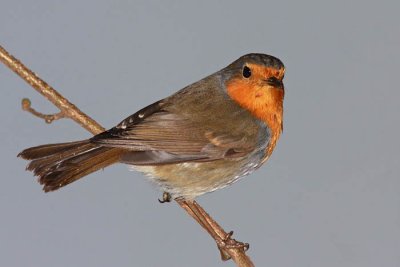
[18,140,123,192]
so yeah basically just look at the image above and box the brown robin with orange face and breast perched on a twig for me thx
[18,53,285,200]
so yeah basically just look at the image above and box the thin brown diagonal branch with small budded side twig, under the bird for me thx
[0,46,254,267]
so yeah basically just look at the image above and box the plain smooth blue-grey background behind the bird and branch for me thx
[0,0,400,267]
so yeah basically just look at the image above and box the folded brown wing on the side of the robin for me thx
[91,101,253,165]
